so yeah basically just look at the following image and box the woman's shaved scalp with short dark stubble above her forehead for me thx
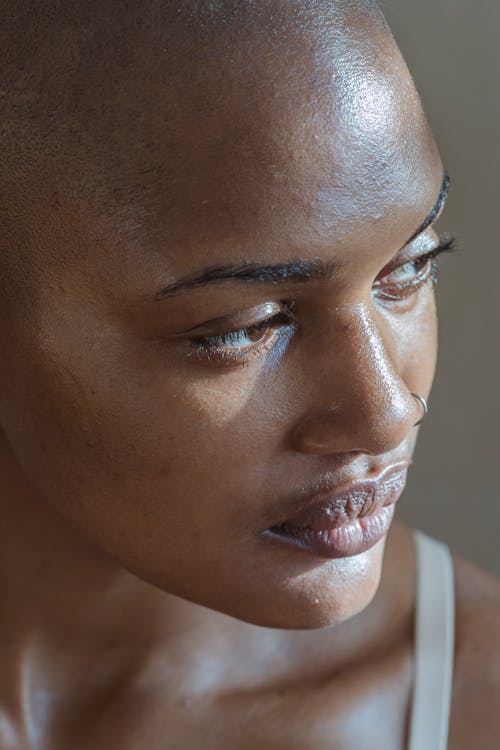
[0,0,402,288]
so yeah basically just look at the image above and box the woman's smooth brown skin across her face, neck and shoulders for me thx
[0,3,500,750]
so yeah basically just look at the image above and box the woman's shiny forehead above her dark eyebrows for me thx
[123,19,442,268]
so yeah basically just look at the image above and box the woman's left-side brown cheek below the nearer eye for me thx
[0,308,282,577]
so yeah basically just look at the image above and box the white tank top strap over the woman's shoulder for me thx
[408,530,455,750]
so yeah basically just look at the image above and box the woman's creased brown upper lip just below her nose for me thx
[267,460,410,531]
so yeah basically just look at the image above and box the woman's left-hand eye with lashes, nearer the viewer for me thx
[189,303,296,366]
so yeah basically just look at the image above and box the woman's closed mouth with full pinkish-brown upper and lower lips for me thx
[263,462,408,559]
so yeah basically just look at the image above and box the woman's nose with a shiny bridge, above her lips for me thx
[293,307,422,455]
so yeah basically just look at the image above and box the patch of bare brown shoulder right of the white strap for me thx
[449,554,500,750]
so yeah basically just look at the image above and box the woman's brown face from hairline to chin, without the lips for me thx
[0,5,443,628]
